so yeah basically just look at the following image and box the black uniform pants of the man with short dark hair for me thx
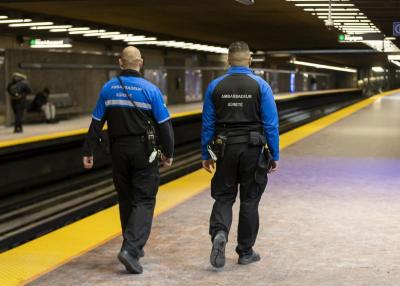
[210,144,267,255]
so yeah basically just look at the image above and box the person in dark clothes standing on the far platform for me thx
[7,72,32,133]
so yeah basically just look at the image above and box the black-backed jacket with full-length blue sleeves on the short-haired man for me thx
[201,66,279,161]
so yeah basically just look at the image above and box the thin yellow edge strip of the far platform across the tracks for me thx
[0,109,201,148]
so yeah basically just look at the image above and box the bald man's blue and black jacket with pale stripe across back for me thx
[84,70,174,158]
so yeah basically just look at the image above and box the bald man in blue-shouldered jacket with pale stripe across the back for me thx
[83,46,174,274]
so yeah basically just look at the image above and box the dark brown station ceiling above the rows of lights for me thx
[0,0,400,66]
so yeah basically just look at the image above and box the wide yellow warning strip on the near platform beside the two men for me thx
[0,89,400,286]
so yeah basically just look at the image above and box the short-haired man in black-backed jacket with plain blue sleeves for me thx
[202,42,279,268]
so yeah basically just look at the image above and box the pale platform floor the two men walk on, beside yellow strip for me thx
[24,93,400,286]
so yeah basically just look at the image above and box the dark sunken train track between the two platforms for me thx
[0,90,362,251]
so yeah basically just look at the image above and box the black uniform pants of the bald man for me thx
[111,136,160,257]
